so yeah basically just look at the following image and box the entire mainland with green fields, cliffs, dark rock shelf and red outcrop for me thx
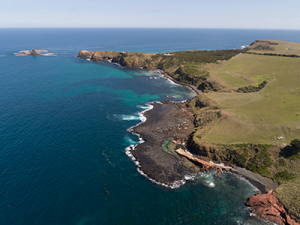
[78,40,300,225]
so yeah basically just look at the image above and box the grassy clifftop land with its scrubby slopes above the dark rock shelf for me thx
[185,40,300,221]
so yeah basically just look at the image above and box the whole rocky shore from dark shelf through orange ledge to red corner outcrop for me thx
[130,101,299,225]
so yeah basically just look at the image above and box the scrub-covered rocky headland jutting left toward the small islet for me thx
[78,49,246,92]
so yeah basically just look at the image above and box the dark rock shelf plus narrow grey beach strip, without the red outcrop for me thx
[131,101,277,191]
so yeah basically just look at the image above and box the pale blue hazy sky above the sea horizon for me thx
[0,0,300,29]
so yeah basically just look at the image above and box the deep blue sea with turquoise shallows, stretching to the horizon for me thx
[0,28,300,225]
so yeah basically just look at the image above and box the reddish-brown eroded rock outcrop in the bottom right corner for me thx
[246,190,300,225]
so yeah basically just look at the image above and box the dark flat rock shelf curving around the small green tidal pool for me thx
[131,101,199,186]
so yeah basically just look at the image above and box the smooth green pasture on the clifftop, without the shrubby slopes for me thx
[202,54,300,144]
